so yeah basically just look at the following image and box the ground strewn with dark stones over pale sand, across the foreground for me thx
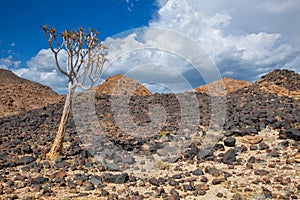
[0,70,300,200]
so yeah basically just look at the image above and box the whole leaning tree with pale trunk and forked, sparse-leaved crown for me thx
[41,26,106,160]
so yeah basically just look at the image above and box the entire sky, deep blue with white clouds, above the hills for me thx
[0,0,300,93]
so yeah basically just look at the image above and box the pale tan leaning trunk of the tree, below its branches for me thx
[47,81,75,160]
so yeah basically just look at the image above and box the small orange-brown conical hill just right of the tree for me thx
[93,74,152,96]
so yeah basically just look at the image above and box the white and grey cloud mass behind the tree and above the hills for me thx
[14,0,300,92]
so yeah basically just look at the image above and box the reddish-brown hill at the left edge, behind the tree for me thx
[0,69,60,117]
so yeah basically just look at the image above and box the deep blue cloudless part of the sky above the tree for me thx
[0,0,158,66]
